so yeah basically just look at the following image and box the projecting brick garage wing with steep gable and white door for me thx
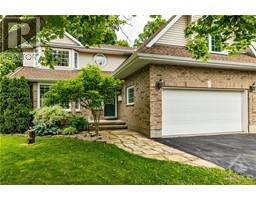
[113,15,256,137]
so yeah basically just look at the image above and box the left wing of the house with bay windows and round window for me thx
[9,33,134,118]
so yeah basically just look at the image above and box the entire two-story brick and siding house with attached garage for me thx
[10,15,256,137]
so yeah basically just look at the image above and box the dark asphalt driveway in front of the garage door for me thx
[155,134,256,178]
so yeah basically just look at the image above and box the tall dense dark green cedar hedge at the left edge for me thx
[0,77,32,133]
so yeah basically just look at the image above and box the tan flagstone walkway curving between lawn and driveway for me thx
[74,130,220,168]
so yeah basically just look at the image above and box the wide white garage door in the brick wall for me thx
[162,89,245,136]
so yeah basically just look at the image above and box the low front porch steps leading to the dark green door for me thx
[89,120,127,130]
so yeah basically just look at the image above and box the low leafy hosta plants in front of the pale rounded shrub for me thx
[31,124,61,136]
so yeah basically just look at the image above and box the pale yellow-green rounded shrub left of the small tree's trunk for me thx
[33,105,70,127]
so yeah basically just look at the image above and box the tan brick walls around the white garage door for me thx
[119,65,256,137]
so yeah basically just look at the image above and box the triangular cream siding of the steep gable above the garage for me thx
[156,16,189,46]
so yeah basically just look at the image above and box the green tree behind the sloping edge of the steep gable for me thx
[134,15,166,47]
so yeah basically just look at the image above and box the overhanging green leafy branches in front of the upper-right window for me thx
[185,15,256,61]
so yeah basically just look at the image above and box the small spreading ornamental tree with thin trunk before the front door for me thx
[44,65,122,135]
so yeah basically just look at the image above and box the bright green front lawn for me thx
[0,135,256,184]
